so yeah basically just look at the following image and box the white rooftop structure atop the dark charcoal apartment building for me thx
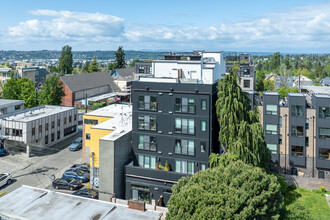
[150,51,226,84]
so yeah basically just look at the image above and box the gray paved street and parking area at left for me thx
[0,132,82,193]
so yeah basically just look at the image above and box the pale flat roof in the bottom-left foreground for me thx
[0,185,162,220]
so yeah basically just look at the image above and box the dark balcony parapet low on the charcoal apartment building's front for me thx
[125,165,189,182]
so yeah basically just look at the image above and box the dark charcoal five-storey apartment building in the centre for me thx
[125,78,220,205]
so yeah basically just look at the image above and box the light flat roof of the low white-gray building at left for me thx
[1,105,75,122]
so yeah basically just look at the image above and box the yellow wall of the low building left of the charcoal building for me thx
[83,115,112,167]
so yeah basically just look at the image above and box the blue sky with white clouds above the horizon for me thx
[0,0,330,53]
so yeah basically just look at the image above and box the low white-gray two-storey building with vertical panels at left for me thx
[0,105,78,155]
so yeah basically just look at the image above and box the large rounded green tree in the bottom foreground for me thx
[166,161,283,220]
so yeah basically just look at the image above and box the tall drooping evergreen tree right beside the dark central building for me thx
[216,65,270,168]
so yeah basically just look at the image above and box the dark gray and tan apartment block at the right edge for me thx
[259,92,330,179]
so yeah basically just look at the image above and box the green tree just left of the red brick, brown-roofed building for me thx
[40,74,65,105]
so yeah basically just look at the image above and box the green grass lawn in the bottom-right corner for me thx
[285,187,330,220]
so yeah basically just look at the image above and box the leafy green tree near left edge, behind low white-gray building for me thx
[3,75,38,108]
